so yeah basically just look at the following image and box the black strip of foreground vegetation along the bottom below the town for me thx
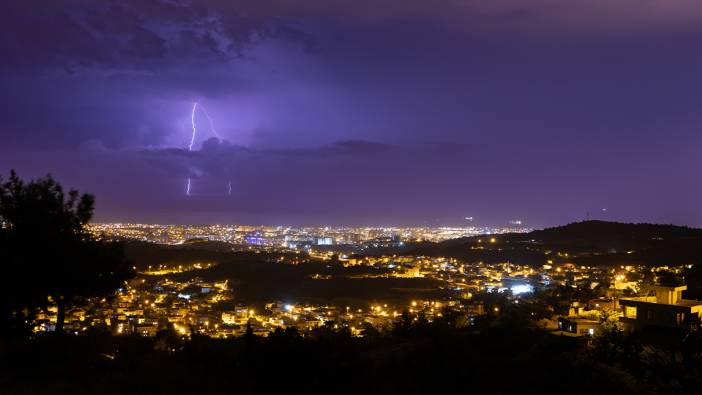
[0,312,702,395]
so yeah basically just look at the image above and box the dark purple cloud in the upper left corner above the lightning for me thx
[0,0,311,71]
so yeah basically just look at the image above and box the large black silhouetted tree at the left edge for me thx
[0,171,133,333]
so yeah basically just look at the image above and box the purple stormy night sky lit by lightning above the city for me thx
[0,0,702,227]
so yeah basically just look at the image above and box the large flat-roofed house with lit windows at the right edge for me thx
[619,285,702,330]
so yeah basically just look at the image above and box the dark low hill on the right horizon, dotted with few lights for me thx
[403,221,702,265]
